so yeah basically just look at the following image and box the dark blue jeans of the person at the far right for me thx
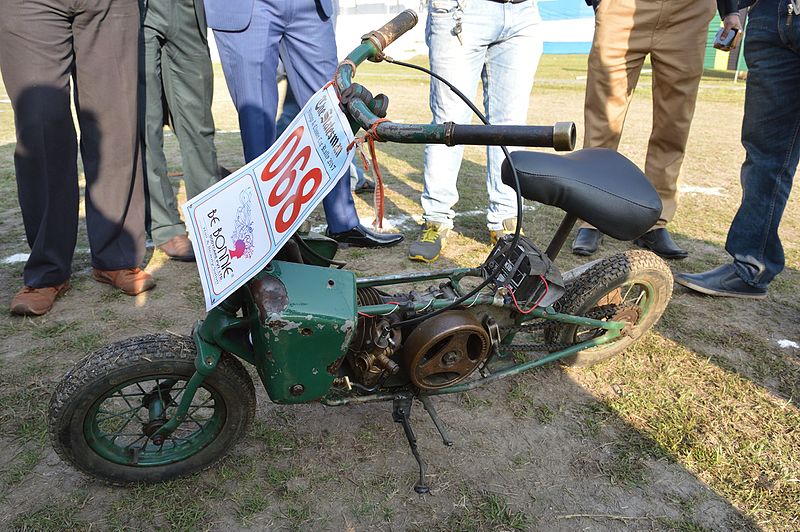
[725,0,800,288]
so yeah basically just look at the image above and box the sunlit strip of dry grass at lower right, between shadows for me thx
[576,335,800,530]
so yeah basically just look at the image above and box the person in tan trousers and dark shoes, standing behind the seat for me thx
[572,0,741,259]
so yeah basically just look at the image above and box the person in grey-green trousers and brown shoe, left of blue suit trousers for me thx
[140,0,219,261]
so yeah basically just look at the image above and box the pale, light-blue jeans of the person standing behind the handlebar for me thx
[422,0,542,229]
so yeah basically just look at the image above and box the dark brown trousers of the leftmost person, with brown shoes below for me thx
[0,0,144,287]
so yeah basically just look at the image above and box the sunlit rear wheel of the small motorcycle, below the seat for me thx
[545,250,672,367]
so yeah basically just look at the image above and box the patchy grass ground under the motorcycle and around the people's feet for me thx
[0,52,800,531]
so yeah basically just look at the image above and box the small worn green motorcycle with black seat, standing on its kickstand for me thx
[49,11,672,493]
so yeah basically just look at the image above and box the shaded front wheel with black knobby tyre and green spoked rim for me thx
[49,334,255,484]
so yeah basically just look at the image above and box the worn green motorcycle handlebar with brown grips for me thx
[334,9,576,151]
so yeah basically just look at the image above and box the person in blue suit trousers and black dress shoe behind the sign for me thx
[205,0,403,247]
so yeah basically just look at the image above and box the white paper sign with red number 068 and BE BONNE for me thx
[183,85,355,310]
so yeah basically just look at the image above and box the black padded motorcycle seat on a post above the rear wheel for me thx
[502,148,661,240]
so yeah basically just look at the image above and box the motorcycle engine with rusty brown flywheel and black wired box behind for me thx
[346,236,565,390]
